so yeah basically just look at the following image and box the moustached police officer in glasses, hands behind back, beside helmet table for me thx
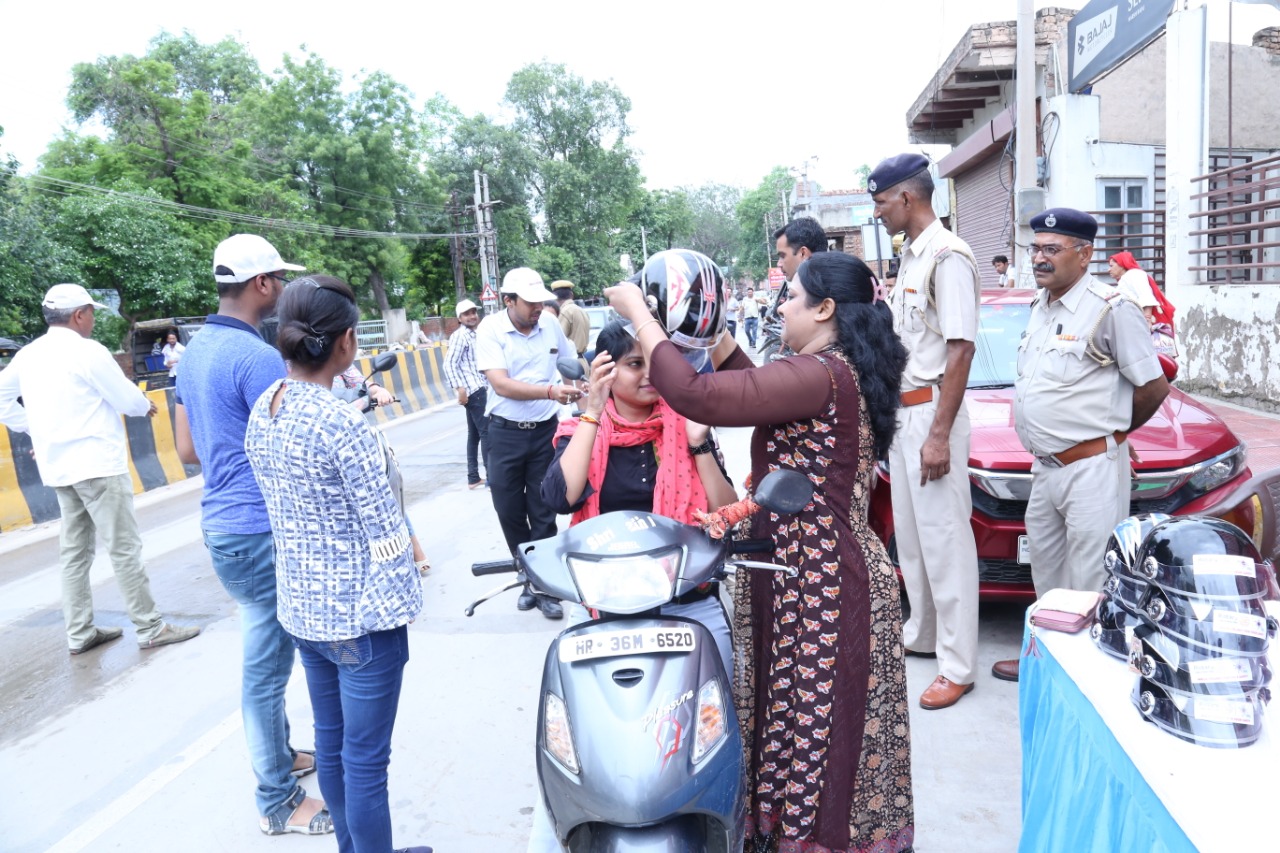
[992,207,1169,681]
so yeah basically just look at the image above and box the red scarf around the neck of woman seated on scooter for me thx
[552,398,707,526]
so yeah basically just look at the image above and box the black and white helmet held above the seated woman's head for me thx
[634,248,728,350]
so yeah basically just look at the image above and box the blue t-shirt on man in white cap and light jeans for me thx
[175,314,284,533]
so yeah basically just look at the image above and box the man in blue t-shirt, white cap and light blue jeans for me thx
[174,234,333,835]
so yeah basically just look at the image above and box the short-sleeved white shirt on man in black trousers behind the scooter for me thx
[475,309,577,421]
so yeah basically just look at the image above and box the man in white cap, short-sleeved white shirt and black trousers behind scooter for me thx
[476,266,582,619]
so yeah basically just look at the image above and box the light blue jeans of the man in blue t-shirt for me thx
[205,530,298,817]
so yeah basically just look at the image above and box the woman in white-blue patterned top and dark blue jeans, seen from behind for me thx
[244,275,430,853]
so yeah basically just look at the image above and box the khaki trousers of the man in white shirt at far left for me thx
[54,474,164,648]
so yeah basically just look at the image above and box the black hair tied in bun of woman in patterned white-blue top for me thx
[275,275,360,368]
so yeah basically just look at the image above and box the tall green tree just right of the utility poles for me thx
[506,63,640,293]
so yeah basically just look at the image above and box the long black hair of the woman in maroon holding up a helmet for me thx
[797,252,906,459]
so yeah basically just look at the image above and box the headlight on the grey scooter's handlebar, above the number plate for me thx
[567,547,684,613]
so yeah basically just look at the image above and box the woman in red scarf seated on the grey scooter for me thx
[543,320,737,674]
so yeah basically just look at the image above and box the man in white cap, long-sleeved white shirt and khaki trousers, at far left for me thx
[0,284,200,654]
